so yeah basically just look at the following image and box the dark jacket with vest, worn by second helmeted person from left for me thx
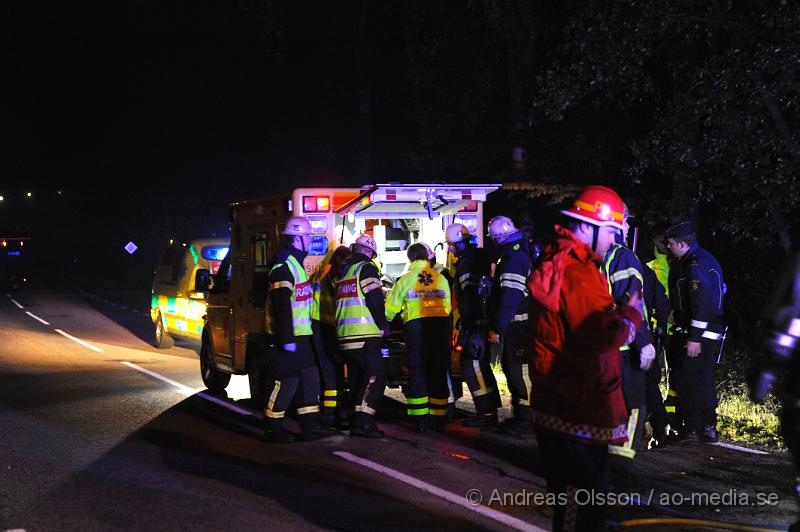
[336,261,383,349]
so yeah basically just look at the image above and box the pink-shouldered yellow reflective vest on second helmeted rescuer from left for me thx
[336,261,381,340]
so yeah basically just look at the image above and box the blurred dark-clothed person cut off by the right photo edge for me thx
[750,255,800,532]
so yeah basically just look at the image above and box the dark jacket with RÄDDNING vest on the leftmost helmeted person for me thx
[267,248,314,343]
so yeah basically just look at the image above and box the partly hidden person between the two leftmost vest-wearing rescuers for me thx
[311,246,350,429]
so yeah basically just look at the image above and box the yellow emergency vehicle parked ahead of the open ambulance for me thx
[150,238,228,349]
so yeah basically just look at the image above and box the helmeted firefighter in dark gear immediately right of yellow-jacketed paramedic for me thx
[445,223,500,428]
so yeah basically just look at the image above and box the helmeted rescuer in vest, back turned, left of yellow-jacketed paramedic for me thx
[336,235,389,438]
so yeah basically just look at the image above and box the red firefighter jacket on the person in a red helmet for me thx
[528,226,642,444]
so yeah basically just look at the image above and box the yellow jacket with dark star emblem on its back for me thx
[386,260,451,322]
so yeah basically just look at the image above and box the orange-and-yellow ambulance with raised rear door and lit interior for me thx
[200,183,500,406]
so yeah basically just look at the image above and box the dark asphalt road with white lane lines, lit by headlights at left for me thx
[0,283,797,531]
